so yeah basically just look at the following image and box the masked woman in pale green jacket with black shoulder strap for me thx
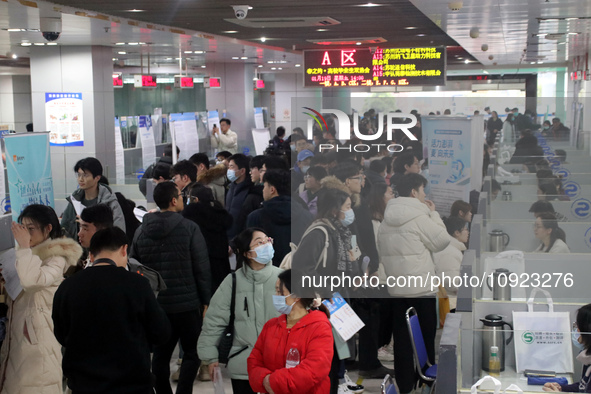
[197,228,281,394]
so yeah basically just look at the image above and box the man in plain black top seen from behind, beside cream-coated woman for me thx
[52,227,170,394]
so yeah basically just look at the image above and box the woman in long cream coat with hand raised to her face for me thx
[0,204,82,394]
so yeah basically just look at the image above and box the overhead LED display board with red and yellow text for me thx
[304,47,446,87]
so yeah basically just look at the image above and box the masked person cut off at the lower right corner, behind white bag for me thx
[544,304,591,393]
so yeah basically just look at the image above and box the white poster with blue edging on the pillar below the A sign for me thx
[45,93,84,146]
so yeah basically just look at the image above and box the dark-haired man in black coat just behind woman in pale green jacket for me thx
[246,170,313,266]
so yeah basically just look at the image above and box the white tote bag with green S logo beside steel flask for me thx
[513,287,573,373]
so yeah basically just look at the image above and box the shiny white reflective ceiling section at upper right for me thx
[410,0,591,67]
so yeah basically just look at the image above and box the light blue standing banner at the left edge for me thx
[4,133,54,221]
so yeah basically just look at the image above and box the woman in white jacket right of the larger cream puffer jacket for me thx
[433,216,470,310]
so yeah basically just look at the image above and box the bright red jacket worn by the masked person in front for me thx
[248,311,334,394]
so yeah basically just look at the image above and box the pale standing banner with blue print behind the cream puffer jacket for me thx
[422,116,484,215]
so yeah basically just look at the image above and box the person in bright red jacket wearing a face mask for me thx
[248,270,333,394]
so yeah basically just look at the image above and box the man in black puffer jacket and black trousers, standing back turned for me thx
[130,182,212,394]
